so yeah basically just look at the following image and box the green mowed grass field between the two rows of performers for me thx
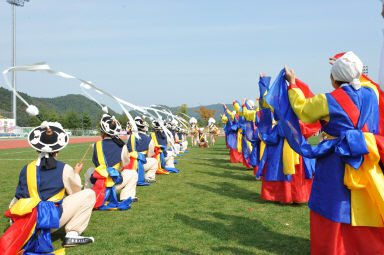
[0,138,310,255]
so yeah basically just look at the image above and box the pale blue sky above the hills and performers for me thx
[0,0,383,111]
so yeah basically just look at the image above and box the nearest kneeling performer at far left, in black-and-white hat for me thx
[0,121,96,255]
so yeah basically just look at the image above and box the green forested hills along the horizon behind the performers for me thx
[0,87,233,128]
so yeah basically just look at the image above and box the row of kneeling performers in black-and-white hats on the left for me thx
[0,114,188,255]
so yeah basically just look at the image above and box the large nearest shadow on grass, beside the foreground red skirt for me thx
[174,213,310,254]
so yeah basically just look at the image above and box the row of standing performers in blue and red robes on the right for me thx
[222,52,384,254]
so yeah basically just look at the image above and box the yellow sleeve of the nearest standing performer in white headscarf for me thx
[288,88,329,123]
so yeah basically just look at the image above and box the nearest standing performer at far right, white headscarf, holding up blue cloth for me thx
[280,52,384,254]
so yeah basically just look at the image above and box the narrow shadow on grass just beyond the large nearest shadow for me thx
[187,182,268,204]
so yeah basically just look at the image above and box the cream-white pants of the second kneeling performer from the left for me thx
[84,168,138,200]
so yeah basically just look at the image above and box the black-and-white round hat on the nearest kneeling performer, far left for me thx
[28,121,69,153]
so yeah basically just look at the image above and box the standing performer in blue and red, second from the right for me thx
[243,74,316,203]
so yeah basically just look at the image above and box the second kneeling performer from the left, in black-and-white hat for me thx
[84,114,138,210]
